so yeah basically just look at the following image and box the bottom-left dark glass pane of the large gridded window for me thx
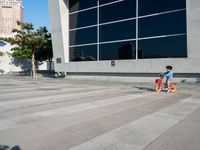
[70,45,97,61]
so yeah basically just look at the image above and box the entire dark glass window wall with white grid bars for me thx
[69,0,187,61]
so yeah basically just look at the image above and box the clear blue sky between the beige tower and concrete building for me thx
[23,0,50,30]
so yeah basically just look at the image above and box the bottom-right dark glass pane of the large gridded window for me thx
[138,35,187,59]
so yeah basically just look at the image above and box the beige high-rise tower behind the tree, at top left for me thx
[0,0,24,36]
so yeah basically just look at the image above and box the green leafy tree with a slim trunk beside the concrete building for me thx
[0,21,53,78]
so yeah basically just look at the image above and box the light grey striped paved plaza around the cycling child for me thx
[0,76,200,150]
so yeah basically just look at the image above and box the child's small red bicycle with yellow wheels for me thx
[155,76,176,92]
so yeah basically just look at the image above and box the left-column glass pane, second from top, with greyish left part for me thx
[69,9,97,29]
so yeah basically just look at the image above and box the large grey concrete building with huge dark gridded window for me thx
[49,0,200,73]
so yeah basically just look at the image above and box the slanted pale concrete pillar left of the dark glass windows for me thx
[48,0,69,67]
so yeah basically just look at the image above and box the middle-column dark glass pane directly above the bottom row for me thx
[100,20,136,42]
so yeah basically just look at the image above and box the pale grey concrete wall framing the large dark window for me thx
[49,0,200,73]
